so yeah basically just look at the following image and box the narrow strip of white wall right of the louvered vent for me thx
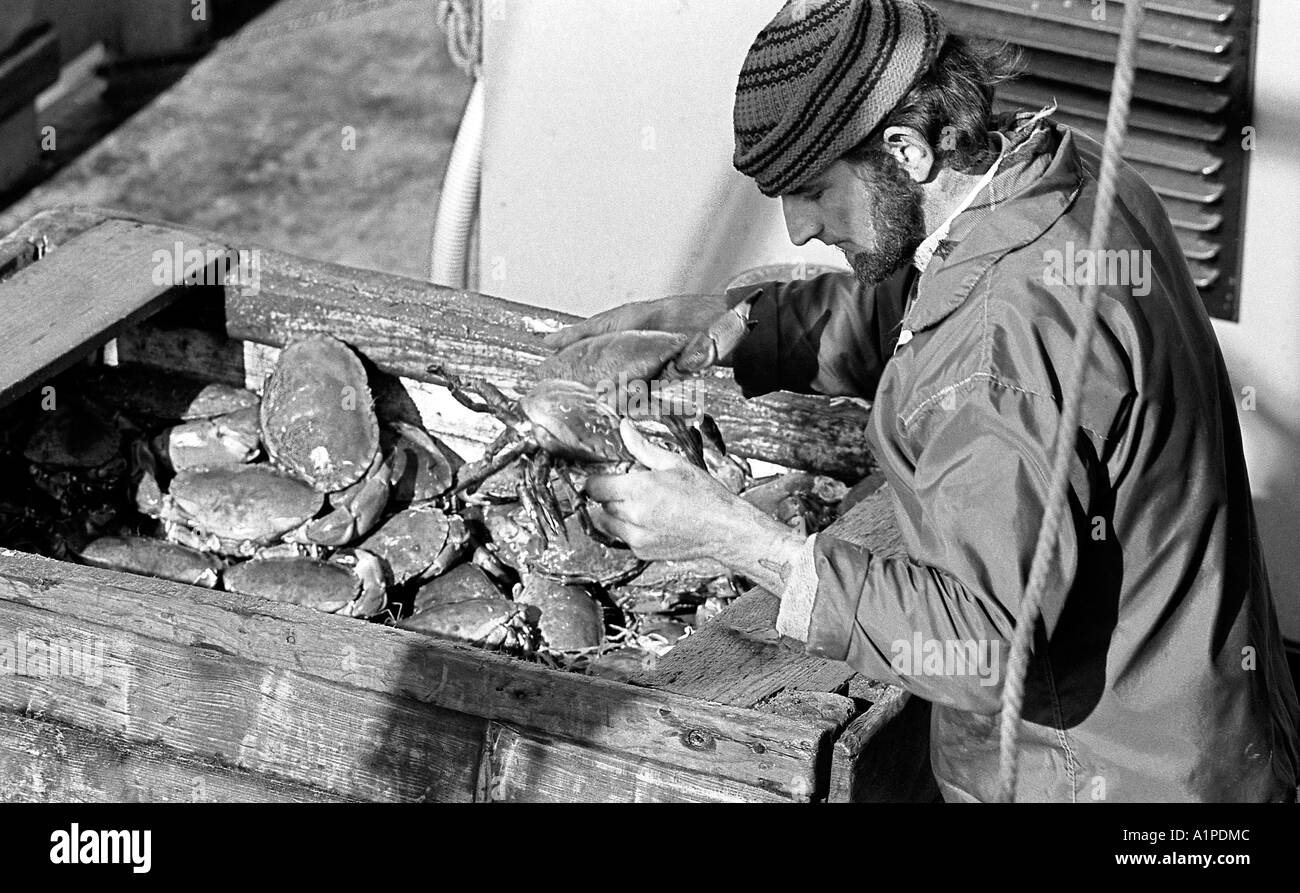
[1216,0,1300,640]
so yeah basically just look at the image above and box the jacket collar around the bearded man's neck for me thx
[902,120,1084,333]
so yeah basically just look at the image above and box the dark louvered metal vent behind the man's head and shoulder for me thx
[927,0,1256,320]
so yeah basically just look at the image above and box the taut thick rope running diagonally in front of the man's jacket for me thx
[998,0,1144,803]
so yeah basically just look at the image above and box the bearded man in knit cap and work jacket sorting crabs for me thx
[550,0,1297,802]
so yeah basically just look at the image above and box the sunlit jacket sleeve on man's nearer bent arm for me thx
[807,378,1089,714]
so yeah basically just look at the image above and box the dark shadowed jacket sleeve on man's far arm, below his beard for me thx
[727,265,914,400]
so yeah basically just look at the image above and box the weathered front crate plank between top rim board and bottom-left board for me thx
[0,593,484,802]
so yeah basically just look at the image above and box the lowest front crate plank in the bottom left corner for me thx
[0,712,353,803]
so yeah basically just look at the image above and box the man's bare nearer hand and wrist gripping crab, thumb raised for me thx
[585,420,803,595]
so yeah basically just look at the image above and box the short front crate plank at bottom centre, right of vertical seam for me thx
[480,723,780,803]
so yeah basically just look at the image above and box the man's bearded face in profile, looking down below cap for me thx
[781,152,926,285]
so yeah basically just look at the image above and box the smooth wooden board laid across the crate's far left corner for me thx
[0,220,226,406]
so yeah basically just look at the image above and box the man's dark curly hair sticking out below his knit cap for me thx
[844,35,1023,172]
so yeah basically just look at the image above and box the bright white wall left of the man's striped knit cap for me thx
[478,0,845,315]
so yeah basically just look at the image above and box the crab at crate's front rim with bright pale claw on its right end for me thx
[222,555,384,617]
